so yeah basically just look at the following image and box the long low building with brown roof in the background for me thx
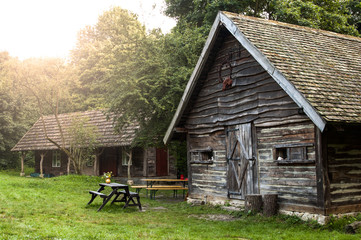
[12,110,175,177]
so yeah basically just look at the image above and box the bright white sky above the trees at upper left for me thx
[0,0,176,60]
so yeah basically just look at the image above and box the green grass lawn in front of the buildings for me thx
[0,172,361,240]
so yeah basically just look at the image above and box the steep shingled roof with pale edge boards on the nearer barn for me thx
[164,12,361,142]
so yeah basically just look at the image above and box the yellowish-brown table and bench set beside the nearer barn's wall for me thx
[132,178,188,199]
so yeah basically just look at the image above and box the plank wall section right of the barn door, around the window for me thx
[257,122,317,209]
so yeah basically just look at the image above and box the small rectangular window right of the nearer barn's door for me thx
[273,143,314,163]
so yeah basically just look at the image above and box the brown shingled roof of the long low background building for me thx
[12,110,138,151]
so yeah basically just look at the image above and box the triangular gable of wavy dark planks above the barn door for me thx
[185,36,306,134]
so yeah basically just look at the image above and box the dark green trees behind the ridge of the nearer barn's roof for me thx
[166,0,360,36]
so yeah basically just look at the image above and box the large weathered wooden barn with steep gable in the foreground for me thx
[164,12,361,221]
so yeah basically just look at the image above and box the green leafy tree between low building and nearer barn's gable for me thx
[110,25,204,146]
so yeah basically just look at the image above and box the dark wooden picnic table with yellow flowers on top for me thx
[88,183,142,212]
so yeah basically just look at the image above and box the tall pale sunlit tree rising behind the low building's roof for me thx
[71,7,145,109]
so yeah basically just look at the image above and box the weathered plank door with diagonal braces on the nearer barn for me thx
[226,123,257,199]
